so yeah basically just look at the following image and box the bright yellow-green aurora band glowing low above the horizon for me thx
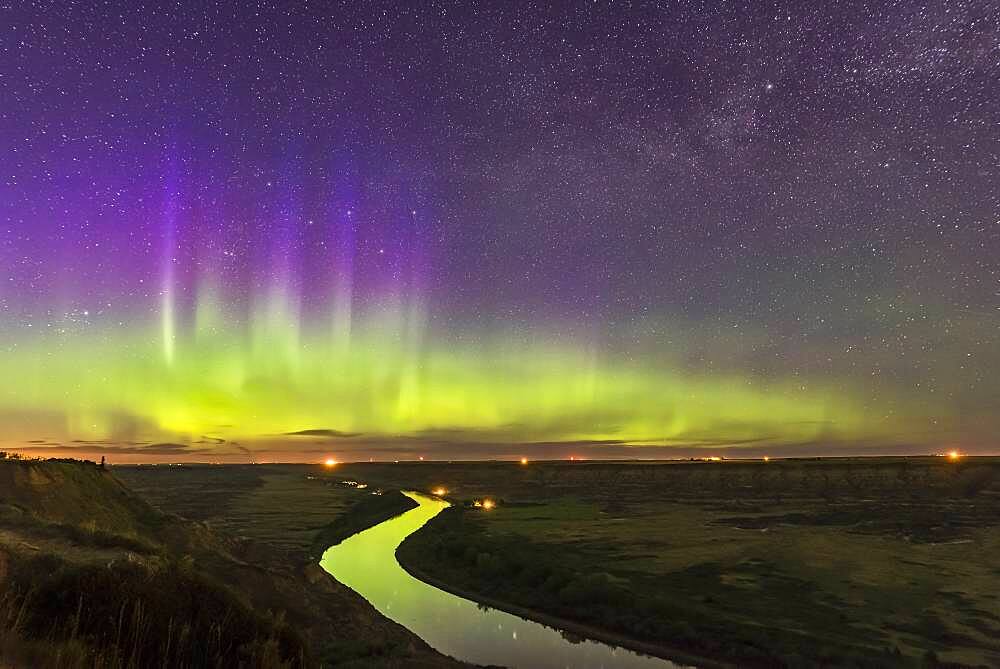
[0,280,980,456]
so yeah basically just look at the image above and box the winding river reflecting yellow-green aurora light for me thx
[320,492,679,669]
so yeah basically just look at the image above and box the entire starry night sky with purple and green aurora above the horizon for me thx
[0,0,1000,460]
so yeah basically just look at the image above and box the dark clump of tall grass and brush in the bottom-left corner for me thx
[0,557,306,669]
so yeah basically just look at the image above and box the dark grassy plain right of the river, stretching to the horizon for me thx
[368,458,1000,667]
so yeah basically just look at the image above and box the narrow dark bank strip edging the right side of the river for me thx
[396,541,720,669]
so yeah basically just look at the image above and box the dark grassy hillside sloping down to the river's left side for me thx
[0,460,460,669]
